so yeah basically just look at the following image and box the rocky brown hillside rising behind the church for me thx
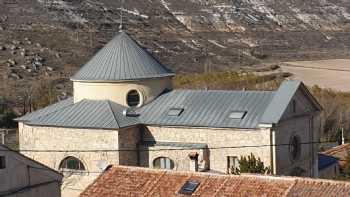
[0,0,350,111]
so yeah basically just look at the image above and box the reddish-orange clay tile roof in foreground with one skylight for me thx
[80,166,350,197]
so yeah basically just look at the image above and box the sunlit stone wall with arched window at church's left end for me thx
[19,123,119,197]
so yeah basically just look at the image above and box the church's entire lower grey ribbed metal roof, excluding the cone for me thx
[16,81,322,129]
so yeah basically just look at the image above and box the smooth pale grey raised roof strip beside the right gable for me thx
[260,81,302,124]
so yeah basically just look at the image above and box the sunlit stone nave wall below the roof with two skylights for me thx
[141,126,271,173]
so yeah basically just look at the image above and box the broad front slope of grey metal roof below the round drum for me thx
[26,100,137,129]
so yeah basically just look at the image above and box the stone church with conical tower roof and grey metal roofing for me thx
[17,32,322,194]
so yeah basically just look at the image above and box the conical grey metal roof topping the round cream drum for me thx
[71,32,174,81]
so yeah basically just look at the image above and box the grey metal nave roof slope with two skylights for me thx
[137,90,274,128]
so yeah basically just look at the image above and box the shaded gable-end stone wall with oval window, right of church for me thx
[275,90,320,177]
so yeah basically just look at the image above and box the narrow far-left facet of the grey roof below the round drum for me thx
[15,97,74,122]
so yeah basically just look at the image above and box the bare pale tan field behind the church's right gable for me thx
[280,59,350,92]
